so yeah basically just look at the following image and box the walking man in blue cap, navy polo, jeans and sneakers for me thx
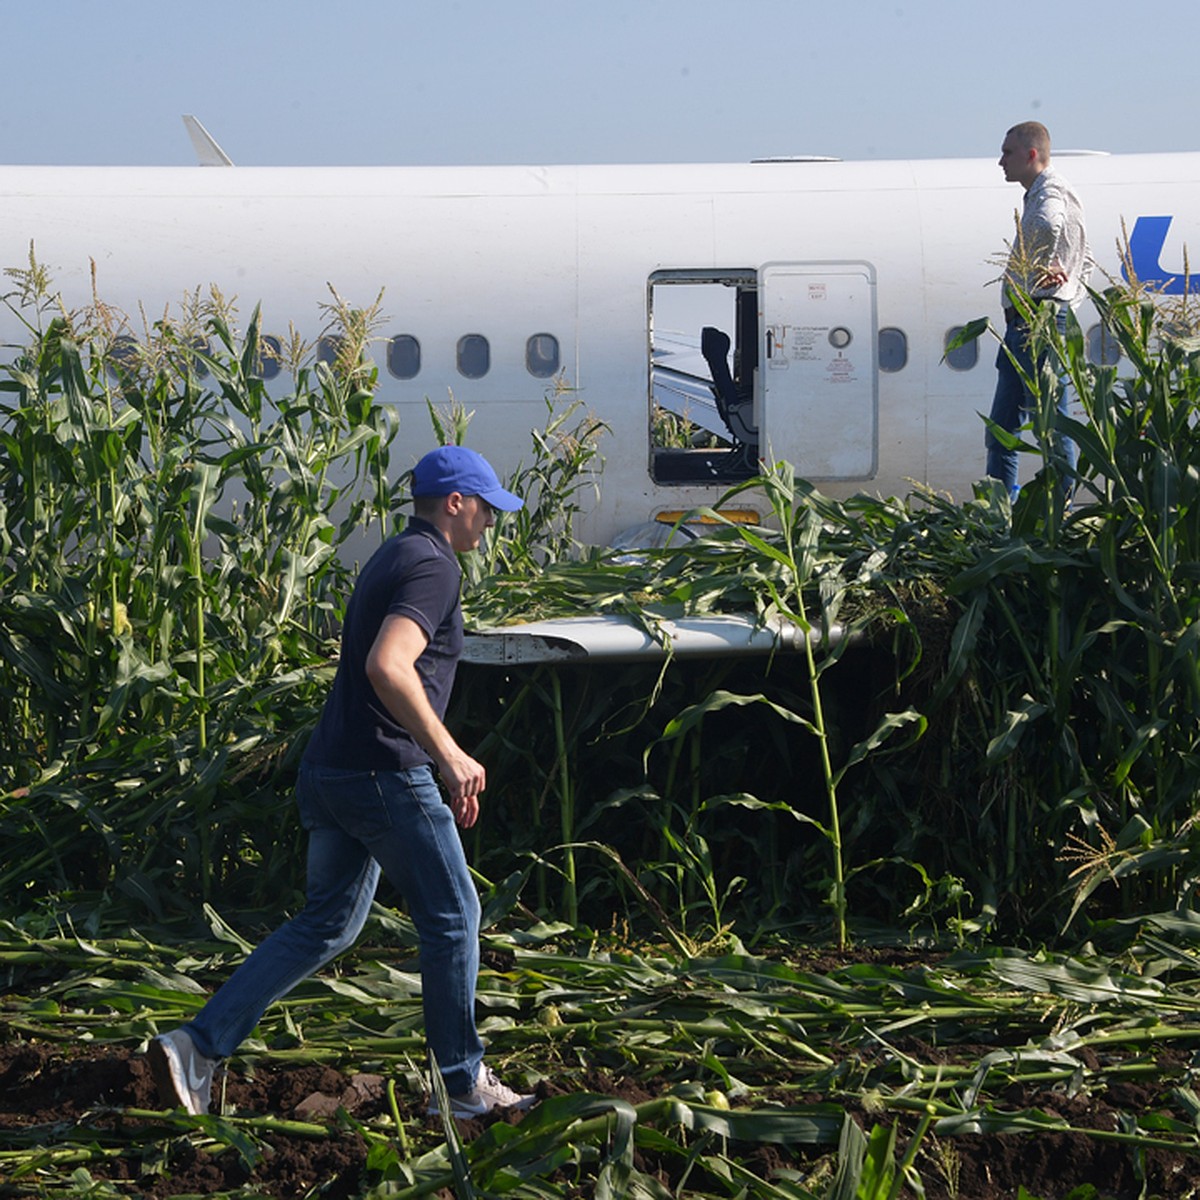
[149,445,534,1118]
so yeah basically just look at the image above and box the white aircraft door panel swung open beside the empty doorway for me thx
[758,263,878,480]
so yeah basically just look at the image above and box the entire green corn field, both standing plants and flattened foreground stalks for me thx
[0,262,1200,1200]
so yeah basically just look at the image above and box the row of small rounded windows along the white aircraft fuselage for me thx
[114,325,1121,379]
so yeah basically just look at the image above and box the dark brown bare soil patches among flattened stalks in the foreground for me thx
[0,1040,1200,1200]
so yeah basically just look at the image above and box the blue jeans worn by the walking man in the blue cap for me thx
[187,766,484,1096]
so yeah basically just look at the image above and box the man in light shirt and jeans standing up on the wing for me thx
[984,121,1092,496]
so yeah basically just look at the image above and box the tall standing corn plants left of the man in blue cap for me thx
[0,272,395,914]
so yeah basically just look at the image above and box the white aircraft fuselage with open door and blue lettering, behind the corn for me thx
[0,154,1200,540]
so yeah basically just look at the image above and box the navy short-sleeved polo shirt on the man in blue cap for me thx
[304,517,462,770]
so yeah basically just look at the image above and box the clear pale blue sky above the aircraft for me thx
[0,0,1200,166]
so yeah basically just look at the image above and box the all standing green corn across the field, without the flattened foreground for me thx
[0,262,1200,947]
